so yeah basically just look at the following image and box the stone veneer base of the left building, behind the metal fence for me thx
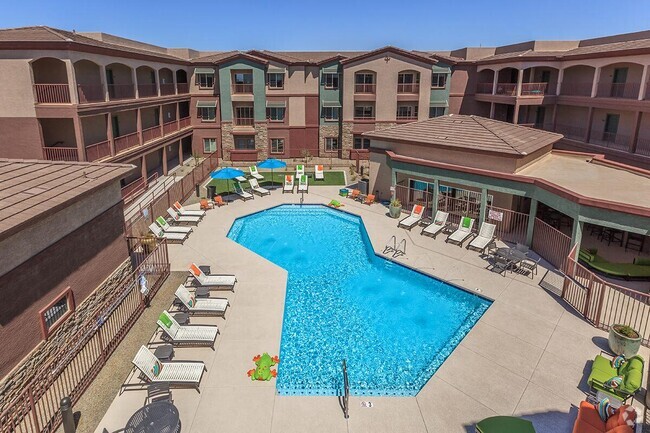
[0,259,133,412]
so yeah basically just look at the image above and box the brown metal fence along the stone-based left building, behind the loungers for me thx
[0,239,169,433]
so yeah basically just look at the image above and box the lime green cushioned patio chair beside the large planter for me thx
[587,355,644,400]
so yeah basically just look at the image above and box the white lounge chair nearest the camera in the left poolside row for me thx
[132,346,206,392]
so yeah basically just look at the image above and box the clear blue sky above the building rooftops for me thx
[0,0,650,51]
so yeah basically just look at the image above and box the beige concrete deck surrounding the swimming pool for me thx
[96,187,650,433]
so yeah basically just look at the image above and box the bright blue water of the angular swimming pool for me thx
[228,205,490,395]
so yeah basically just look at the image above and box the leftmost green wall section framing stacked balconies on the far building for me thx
[219,59,266,122]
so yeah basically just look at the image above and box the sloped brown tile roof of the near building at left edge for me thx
[0,158,134,239]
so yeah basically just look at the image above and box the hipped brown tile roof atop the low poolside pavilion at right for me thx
[364,114,562,156]
